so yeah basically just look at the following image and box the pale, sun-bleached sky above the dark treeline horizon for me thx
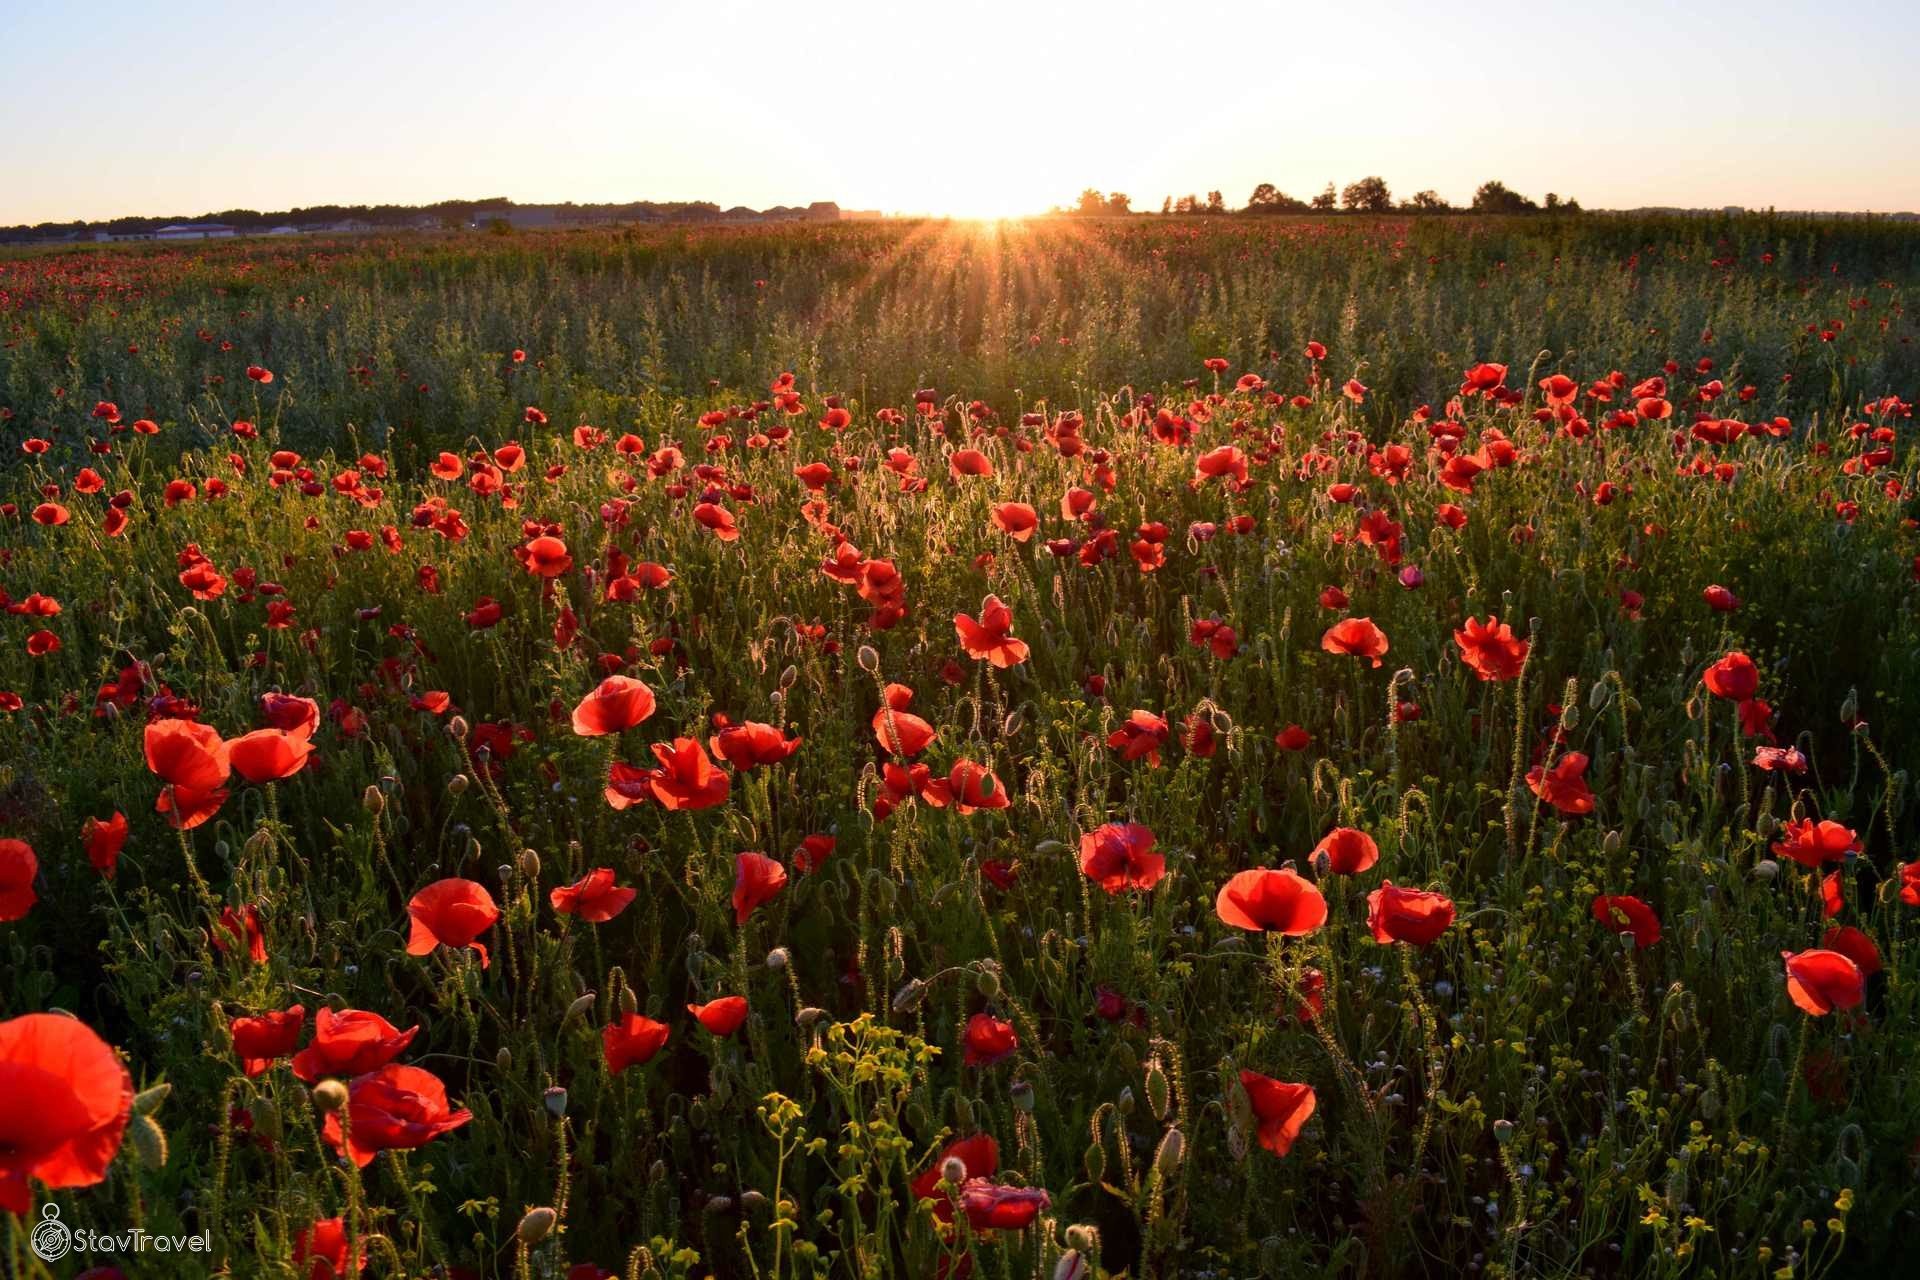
[0,0,1920,225]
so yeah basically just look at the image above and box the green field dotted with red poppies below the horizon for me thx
[0,215,1920,1280]
